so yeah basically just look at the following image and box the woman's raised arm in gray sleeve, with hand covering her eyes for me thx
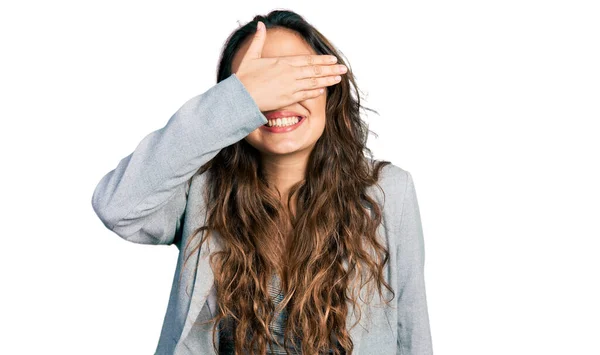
[92,22,350,250]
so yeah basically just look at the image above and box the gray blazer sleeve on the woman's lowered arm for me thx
[397,171,433,355]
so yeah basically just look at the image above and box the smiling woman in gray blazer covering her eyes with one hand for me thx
[92,11,432,355]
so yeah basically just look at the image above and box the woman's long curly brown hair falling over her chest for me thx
[179,10,395,354]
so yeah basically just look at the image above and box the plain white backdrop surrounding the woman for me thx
[0,0,600,355]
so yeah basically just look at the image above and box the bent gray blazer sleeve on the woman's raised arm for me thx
[92,74,267,248]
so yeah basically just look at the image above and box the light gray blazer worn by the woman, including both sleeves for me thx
[92,74,433,355]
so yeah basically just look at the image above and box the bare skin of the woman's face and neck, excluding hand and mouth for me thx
[232,28,327,209]
